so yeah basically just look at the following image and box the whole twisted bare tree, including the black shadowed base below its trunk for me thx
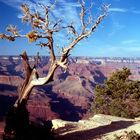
[0,0,109,139]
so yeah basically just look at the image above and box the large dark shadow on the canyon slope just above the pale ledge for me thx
[37,85,87,121]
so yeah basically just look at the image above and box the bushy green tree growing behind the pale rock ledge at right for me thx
[92,68,140,118]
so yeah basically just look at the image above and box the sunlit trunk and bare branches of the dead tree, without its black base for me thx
[0,0,109,128]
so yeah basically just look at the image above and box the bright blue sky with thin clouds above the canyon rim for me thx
[0,0,140,57]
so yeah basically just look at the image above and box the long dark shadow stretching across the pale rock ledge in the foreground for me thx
[57,121,134,140]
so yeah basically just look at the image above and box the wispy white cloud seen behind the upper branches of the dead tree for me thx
[0,0,106,53]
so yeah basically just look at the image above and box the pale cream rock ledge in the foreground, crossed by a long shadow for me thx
[52,114,140,140]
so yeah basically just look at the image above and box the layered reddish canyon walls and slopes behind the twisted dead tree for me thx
[0,57,140,121]
